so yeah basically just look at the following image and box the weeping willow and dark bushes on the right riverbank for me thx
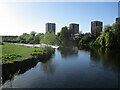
[79,22,120,48]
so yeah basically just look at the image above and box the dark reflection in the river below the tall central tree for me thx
[58,46,78,58]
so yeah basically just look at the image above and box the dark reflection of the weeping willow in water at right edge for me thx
[90,48,120,68]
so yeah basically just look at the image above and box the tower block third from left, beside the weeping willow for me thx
[91,21,103,37]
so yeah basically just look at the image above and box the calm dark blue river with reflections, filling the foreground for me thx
[2,46,120,88]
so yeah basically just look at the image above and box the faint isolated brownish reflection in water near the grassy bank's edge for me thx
[40,59,56,75]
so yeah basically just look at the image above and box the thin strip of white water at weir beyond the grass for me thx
[14,43,60,48]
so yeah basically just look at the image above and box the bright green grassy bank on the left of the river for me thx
[0,43,46,64]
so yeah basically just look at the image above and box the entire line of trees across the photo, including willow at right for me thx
[3,22,120,47]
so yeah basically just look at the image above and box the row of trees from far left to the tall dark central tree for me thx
[2,26,78,45]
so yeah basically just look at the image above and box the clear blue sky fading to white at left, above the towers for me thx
[0,2,118,35]
